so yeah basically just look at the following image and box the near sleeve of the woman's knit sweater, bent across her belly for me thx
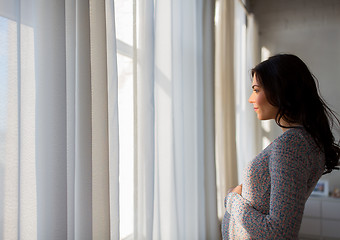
[226,132,308,239]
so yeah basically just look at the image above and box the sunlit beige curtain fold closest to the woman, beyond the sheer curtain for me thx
[215,0,238,220]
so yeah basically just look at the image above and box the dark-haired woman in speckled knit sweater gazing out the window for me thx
[222,54,340,239]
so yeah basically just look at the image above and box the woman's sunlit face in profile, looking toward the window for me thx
[248,74,278,120]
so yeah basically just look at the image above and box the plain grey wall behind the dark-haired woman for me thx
[248,0,340,190]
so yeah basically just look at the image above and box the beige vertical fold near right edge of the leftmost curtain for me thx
[90,1,111,239]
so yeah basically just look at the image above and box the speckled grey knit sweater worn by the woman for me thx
[222,127,325,240]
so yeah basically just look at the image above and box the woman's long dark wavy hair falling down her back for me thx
[251,54,340,174]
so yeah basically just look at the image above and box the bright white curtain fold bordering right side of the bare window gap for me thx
[134,0,155,239]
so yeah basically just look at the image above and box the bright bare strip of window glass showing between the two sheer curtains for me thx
[115,0,134,240]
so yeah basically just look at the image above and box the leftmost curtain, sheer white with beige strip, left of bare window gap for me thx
[0,0,119,240]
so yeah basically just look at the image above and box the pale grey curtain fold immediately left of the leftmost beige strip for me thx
[72,1,93,239]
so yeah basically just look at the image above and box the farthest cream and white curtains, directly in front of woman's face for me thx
[215,0,261,229]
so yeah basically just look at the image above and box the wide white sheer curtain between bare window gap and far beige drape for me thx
[135,0,219,239]
